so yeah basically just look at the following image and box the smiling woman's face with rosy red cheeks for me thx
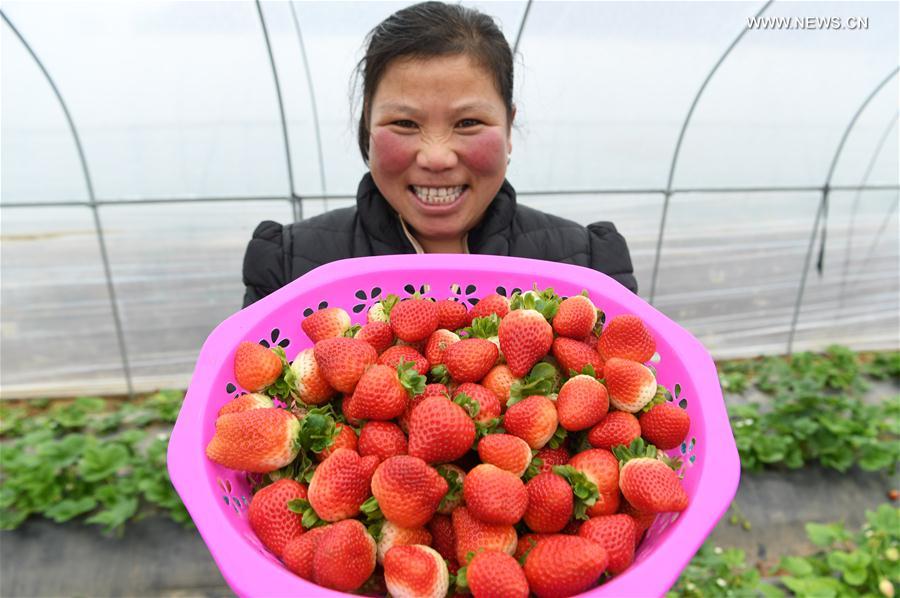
[369,55,512,250]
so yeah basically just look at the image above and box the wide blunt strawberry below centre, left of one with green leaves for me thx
[463,463,528,525]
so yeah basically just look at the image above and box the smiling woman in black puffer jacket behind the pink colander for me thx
[244,2,637,307]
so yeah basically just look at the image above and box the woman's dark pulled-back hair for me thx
[355,2,513,164]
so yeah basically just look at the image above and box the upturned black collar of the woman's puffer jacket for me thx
[356,172,516,253]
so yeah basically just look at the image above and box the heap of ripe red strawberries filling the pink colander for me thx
[206,288,690,598]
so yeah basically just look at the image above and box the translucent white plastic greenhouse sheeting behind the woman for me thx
[0,1,900,397]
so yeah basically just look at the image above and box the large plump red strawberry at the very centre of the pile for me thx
[409,397,475,463]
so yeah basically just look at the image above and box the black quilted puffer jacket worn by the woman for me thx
[244,173,637,307]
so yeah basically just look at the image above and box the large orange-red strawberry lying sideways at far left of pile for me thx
[206,407,300,473]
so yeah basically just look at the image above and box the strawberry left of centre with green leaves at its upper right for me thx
[350,362,425,421]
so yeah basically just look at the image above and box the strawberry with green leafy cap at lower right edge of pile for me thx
[612,438,688,513]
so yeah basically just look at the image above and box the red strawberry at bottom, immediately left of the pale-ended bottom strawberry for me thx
[313,519,375,592]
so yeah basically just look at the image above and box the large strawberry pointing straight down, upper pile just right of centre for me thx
[499,309,553,378]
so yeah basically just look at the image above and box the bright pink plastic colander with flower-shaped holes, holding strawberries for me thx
[168,254,740,598]
